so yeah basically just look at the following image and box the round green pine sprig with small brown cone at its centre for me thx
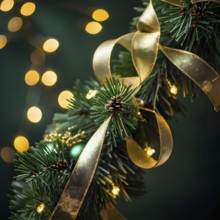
[91,78,137,140]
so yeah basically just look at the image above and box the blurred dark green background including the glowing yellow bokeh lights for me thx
[0,0,220,220]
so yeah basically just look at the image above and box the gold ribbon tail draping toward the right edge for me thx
[160,46,220,111]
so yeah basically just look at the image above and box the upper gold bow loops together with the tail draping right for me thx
[93,0,220,111]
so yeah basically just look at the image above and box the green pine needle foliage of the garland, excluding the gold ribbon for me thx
[10,0,220,220]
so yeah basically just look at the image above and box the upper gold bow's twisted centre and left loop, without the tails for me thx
[93,0,160,87]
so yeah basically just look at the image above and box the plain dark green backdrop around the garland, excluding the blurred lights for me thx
[0,0,220,220]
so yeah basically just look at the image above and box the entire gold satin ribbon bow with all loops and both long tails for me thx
[50,0,220,220]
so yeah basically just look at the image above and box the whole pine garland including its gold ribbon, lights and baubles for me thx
[10,0,220,220]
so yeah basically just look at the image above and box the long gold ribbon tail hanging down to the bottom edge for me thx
[50,118,111,220]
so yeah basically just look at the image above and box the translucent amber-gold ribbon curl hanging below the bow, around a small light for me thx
[126,109,173,169]
